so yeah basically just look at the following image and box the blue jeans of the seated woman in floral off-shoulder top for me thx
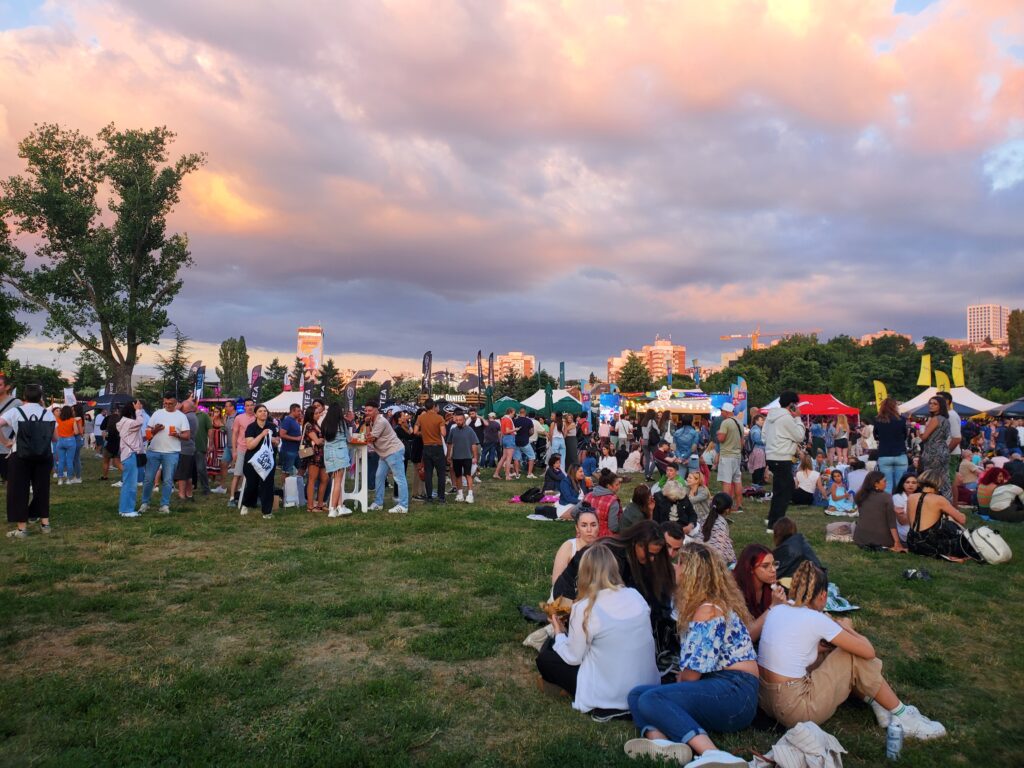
[629,670,758,743]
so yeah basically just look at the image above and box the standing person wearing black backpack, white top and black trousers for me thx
[0,384,57,539]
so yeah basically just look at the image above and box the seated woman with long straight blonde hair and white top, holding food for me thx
[537,544,660,712]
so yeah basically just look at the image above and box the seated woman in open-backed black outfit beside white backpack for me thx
[906,469,973,562]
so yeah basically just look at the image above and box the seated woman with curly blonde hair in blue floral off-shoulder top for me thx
[625,544,758,768]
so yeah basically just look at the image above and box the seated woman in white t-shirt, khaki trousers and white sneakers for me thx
[758,561,946,739]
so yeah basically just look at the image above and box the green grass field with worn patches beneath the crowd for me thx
[0,455,1024,768]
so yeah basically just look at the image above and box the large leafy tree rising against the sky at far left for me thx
[0,124,205,392]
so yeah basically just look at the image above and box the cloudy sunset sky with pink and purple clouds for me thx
[0,0,1024,376]
